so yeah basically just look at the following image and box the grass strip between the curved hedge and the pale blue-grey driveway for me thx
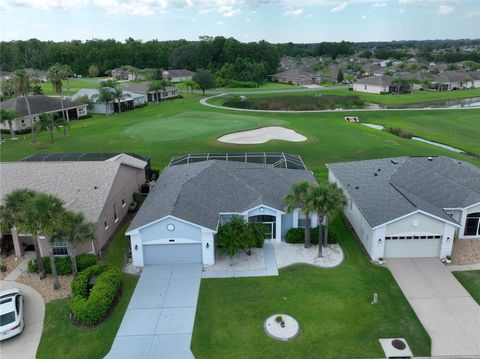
[37,225,138,359]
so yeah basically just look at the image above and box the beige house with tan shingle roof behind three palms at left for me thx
[0,154,147,256]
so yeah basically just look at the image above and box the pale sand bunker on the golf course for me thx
[218,126,307,145]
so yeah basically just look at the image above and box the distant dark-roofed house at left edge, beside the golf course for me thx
[0,95,88,132]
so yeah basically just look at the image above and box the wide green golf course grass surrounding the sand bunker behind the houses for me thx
[0,95,480,173]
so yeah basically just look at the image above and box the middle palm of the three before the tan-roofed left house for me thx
[22,193,65,290]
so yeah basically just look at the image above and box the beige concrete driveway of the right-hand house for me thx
[386,258,480,357]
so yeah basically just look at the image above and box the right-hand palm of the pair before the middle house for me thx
[308,183,347,257]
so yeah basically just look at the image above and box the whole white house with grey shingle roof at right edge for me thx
[327,157,480,260]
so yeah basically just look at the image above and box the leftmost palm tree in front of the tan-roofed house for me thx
[0,189,45,279]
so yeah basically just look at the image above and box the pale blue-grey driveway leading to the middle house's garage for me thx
[106,264,202,359]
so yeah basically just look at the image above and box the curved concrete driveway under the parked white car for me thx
[0,281,45,359]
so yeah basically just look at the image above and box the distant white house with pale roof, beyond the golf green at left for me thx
[72,89,147,114]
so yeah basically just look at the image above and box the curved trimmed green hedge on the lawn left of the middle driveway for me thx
[69,264,122,326]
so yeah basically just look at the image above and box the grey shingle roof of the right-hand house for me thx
[327,156,480,227]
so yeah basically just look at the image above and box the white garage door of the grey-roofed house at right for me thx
[384,236,442,258]
